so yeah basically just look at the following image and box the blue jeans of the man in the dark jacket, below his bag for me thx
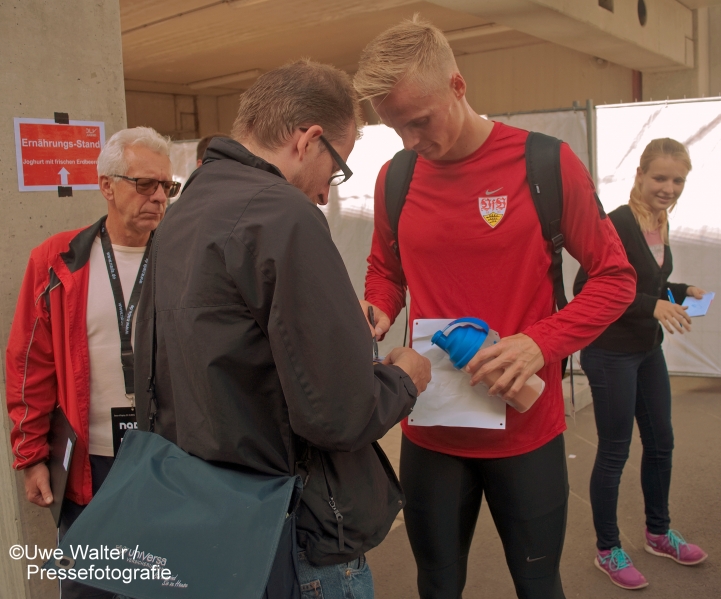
[298,551,373,599]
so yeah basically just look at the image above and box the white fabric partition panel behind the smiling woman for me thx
[596,99,721,376]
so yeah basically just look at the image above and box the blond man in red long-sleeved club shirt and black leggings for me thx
[355,18,635,599]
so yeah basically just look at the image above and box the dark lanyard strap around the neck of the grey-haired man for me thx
[100,221,152,399]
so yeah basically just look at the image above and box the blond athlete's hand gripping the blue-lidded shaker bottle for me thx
[464,333,545,400]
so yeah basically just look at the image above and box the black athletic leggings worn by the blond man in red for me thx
[401,435,568,599]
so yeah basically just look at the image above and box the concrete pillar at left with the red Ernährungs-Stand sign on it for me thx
[0,0,125,599]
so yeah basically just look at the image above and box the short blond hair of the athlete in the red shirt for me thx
[353,13,457,100]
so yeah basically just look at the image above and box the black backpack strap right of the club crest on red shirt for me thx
[526,132,568,310]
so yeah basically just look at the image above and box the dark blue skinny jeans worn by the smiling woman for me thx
[581,347,673,551]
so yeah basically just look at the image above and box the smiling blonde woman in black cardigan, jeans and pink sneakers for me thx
[574,138,707,589]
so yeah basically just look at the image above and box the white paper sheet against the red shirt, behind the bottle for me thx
[408,318,506,429]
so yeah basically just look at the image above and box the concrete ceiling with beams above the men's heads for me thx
[120,0,700,95]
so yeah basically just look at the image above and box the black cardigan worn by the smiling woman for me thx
[573,204,688,353]
